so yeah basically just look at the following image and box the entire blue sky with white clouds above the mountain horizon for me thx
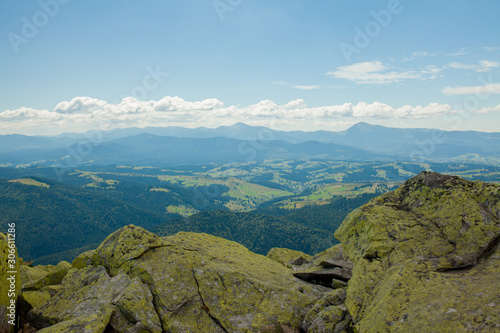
[0,0,500,135]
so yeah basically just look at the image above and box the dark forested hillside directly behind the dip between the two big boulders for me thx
[154,194,376,255]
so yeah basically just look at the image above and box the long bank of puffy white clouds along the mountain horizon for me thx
[0,95,480,135]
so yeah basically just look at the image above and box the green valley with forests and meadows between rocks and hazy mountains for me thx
[0,159,500,263]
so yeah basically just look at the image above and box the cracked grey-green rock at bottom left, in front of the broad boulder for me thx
[28,266,161,333]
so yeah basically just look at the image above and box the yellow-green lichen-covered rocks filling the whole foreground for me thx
[0,172,500,333]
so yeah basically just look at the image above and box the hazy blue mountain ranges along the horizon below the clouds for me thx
[0,123,500,166]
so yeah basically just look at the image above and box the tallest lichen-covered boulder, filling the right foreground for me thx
[335,172,500,332]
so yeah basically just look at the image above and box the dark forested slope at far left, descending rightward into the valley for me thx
[0,178,163,260]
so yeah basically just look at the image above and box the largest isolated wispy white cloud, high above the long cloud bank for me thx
[326,61,422,84]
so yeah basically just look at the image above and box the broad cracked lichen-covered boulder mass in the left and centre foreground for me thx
[28,225,332,332]
